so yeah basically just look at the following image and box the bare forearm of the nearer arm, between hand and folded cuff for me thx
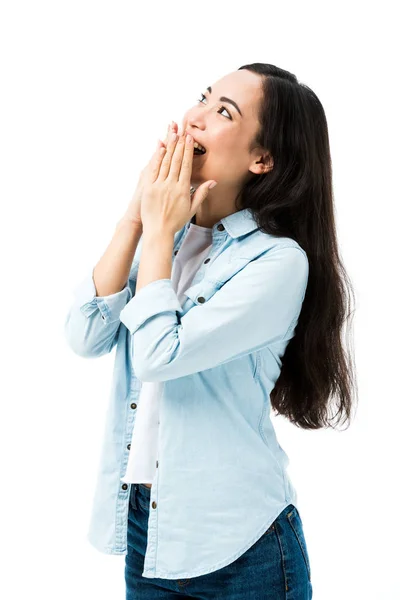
[136,230,174,293]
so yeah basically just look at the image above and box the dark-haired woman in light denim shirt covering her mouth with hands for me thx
[66,63,354,600]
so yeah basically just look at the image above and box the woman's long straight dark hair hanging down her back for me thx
[236,63,357,429]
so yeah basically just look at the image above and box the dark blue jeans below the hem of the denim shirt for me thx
[125,483,312,600]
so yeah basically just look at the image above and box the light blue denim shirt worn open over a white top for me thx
[65,209,308,579]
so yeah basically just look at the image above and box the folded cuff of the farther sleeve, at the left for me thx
[74,270,132,323]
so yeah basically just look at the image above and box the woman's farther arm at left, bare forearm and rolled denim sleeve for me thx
[64,219,141,358]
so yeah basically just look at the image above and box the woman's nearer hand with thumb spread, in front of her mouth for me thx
[141,134,217,234]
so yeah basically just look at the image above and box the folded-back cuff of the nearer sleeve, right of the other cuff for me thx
[120,279,182,334]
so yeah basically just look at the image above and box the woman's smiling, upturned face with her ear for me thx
[182,69,272,194]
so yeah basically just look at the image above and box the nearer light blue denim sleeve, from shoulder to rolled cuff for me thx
[120,246,309,381]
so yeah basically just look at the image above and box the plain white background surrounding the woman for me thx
[0,0,400,600]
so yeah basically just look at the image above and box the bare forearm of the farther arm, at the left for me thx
[93,219,142,296]
